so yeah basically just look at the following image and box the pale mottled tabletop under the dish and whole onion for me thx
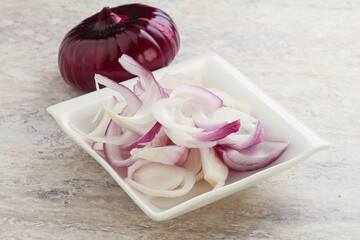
[0,0,360,239]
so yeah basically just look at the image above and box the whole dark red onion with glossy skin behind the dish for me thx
[58,4,180,92]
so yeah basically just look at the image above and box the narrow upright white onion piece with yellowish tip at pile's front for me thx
[200,148,229,188]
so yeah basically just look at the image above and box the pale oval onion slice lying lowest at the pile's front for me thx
[125,160,195,197]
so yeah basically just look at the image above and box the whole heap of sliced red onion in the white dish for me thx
[86,55,288,197]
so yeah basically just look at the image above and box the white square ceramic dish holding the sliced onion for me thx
[47,53,329,221]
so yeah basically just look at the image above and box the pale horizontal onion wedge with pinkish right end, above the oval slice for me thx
[130,145,190,166]
